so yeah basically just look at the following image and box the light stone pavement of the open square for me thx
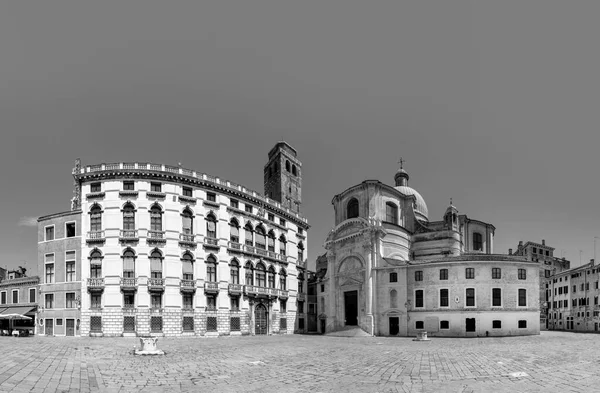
[0,332,600,393]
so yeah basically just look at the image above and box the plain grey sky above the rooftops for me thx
[0,0,600,274]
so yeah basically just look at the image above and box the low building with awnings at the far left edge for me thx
[0,270,39,334]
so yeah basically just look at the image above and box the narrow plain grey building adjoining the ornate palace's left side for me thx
[36,209,82,336]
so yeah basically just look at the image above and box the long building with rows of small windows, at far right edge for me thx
[543,259,600,332]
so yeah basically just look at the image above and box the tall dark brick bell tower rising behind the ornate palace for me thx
[264,142,302,213]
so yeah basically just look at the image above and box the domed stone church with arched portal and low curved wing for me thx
[317,161,540,337]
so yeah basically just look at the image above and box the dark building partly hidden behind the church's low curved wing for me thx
[508,239,571,330]
